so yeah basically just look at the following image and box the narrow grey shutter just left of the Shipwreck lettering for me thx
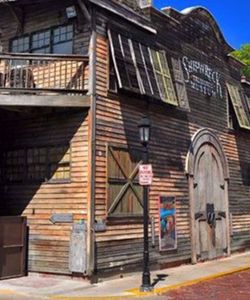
[171,57,190,110]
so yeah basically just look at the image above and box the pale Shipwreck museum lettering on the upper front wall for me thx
[182,56,223,98]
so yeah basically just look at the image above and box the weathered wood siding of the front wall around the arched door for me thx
[92,7,250,270]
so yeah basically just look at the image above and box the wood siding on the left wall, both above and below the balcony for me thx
[0,0,90,274]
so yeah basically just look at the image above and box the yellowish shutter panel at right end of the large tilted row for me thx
[151,49,178,105]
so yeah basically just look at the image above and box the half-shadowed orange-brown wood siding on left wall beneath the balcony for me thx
[1,111,88,274]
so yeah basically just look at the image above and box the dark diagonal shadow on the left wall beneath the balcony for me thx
[0,109,86,216]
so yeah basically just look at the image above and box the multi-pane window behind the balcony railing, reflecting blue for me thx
[10,24,73,54]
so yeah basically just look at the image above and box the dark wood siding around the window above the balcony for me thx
[0,0,90,54]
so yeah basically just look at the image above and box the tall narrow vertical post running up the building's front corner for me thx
[86,6,97,277]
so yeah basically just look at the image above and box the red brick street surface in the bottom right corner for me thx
[164,270,250,300]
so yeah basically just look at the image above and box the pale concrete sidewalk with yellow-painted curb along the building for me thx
[0,252,250,300]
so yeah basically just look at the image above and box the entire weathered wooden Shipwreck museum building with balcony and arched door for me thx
[0,0,250,276]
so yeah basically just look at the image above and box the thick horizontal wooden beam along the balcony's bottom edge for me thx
[0,94,90,107]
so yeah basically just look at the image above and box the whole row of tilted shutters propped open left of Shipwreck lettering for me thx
[108,30,178,105]
